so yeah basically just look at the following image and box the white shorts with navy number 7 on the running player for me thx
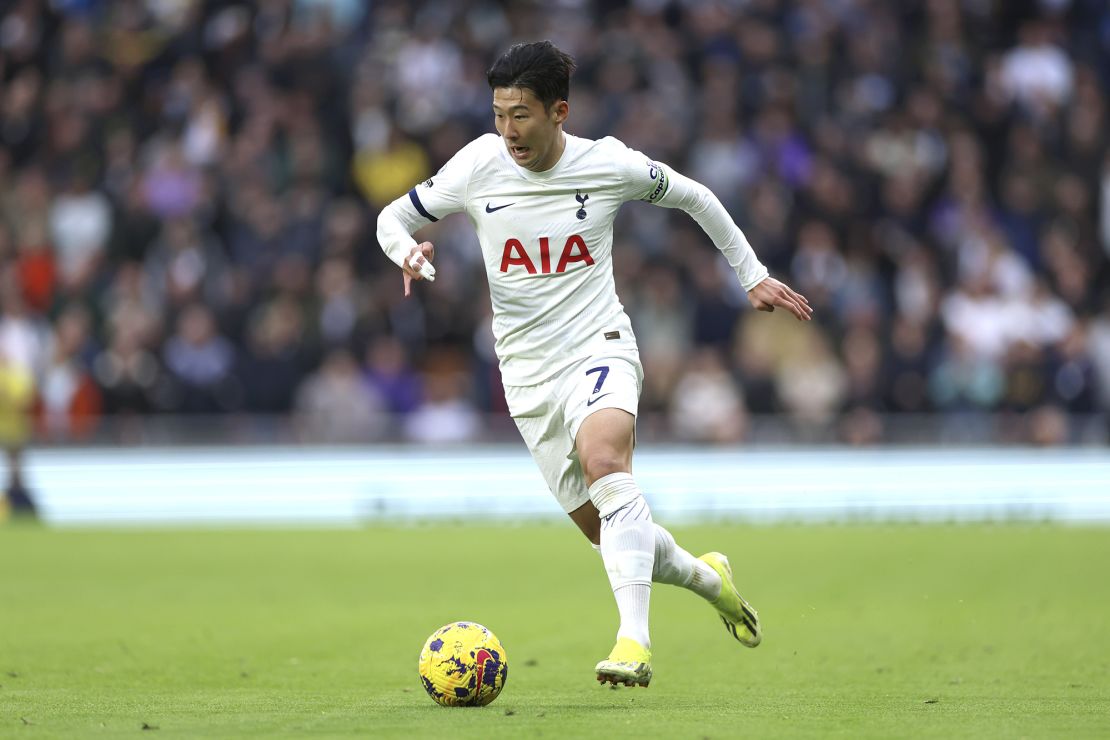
[505,355,644,514]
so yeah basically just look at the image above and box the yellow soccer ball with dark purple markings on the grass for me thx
[420,621,508,707]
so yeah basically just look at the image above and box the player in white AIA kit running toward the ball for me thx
[377,41,811,686]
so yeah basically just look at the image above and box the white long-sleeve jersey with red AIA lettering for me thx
[377,133,767,385]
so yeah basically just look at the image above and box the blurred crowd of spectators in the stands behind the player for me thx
[0,0,1110,452]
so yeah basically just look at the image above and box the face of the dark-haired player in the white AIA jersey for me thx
[493,88,569,172]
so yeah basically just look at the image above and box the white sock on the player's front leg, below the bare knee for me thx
[589,473,655,648]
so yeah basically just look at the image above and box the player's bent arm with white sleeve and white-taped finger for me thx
[377,146,472,296]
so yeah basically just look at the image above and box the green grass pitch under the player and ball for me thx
[0,523,1110,739]
